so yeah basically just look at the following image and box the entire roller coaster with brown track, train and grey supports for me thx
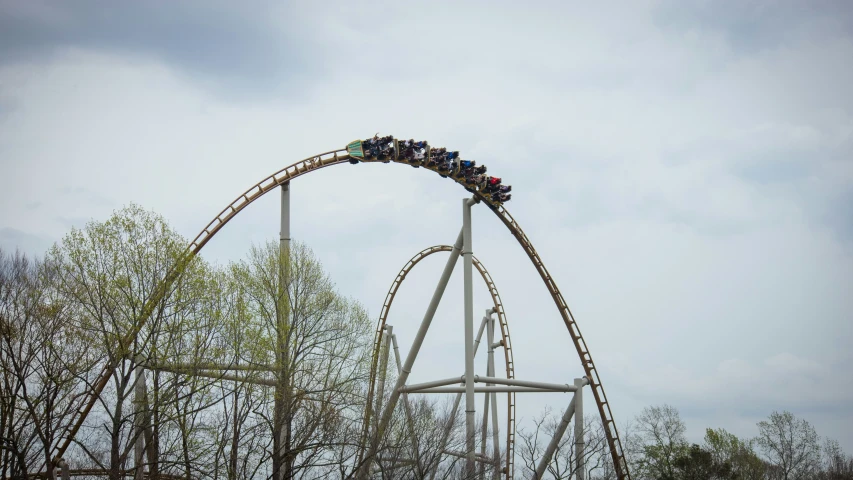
[48,135,631,480]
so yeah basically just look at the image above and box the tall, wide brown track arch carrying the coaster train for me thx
[54,141,631,480]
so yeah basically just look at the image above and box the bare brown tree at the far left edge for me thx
[0,251,96,477]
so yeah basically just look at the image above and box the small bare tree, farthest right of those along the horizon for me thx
[756,412,820,480]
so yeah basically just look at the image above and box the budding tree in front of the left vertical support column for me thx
[231,242,372,479]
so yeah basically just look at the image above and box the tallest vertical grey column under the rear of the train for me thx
[462,199,477,479]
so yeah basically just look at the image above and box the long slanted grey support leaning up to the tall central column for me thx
[357,232,463,479]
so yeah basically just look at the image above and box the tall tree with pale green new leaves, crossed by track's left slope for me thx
[48,205,213,480]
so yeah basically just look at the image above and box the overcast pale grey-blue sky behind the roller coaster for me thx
[0,0,853,453]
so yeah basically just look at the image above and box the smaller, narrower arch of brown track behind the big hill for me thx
[362,245,515,478]
